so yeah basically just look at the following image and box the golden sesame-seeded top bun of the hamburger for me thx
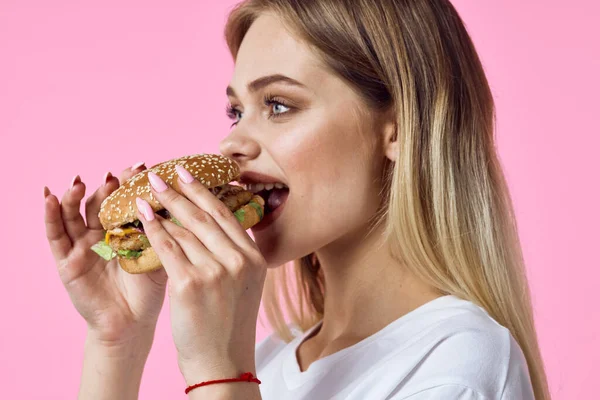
[98,154,240,230]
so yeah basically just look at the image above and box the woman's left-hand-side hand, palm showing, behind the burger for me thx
[44,164,167,351]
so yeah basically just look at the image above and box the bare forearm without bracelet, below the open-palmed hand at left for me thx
[78,334,153,400]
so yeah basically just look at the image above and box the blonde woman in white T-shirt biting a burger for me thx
[46,0,550,400]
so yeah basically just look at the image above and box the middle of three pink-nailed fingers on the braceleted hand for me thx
[148,172,237,263]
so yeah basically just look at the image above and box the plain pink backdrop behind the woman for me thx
[0,0,600,399]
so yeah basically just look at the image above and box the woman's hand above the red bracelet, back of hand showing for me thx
[137,166,267,384]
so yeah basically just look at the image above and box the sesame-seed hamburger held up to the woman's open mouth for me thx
[92,154,265,274]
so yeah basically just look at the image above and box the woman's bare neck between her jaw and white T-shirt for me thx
[315,220,441,347]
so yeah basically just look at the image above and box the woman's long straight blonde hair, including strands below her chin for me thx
[225,0,550,400]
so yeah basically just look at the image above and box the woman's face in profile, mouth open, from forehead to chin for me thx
[221,14,384,267]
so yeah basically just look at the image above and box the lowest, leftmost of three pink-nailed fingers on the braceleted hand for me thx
[135,197,191,282]
